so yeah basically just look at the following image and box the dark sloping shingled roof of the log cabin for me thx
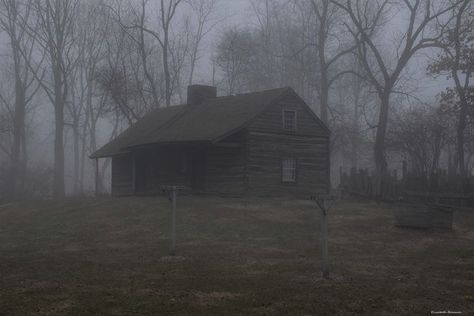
[91,88,324,158]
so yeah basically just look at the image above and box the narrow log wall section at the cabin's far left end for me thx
[112,153,134,196]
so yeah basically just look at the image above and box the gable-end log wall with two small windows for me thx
[247,99,329,197]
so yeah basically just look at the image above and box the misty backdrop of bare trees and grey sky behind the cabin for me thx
[0,0,474,198]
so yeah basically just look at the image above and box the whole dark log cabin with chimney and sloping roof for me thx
[91,85,330,197]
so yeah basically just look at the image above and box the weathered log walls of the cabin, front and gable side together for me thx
[112,96,329,198]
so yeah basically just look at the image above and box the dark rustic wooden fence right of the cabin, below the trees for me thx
[339,168,474,208]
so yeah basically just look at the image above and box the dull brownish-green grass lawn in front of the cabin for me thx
[0,197,474,315]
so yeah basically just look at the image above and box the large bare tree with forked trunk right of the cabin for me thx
[333,0,455,195]
